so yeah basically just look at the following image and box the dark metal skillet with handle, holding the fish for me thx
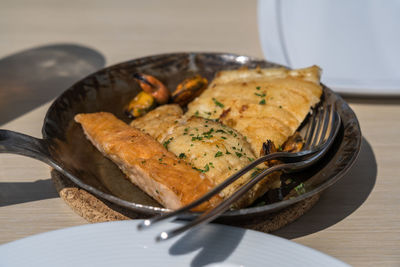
[0,53,361,221]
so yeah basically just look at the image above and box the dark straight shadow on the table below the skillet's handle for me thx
[0,179,59,207]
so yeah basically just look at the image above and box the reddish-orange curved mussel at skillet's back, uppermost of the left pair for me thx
[133,73,170,104]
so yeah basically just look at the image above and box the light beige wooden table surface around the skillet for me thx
[0,0,400,266]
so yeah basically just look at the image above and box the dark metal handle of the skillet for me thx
[0,129,54,165]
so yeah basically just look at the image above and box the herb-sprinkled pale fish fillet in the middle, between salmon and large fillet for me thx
[131,105,280,209]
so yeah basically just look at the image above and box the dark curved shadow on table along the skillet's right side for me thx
[272,138,377,239]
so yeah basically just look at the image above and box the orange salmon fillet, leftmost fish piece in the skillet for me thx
[75,112,221,210]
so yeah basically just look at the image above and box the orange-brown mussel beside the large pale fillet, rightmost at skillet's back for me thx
[172,75,208,107]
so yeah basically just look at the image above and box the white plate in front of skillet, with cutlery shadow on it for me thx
[0,221,348,267]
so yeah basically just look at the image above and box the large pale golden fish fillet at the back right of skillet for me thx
[185,66,322,154]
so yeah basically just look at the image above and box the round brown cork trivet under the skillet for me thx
[51,170,320,233]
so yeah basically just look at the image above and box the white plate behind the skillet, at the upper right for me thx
[258,0,400,95]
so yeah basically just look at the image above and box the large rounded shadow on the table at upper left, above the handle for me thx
[0,44,105,125]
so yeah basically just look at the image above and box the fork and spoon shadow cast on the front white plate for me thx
[169,225,246,267]
